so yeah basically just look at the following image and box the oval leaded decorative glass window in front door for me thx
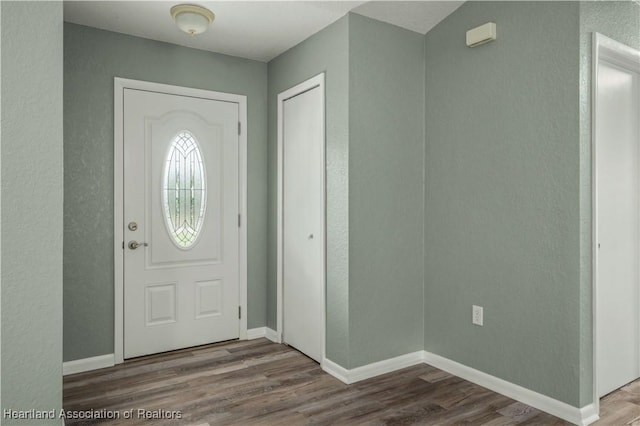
[162,130,207,249]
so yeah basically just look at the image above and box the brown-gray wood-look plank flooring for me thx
[64,339,640,426]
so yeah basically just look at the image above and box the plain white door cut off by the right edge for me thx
[596,61,640,396]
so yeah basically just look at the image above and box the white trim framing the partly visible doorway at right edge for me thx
[591,32,640,414]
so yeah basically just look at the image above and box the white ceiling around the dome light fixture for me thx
[64,0,464,62]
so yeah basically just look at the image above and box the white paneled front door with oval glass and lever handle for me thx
[123,88,240,358]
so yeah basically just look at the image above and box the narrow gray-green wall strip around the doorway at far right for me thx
[580,1,640,406]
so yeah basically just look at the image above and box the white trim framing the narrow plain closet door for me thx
[276,73,327,365]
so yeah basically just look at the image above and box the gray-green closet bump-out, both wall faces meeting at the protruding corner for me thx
[268,14,424,368]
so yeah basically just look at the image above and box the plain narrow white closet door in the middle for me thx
[280,75,325,362]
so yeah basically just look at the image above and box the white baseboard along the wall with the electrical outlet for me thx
[424,351,598,426]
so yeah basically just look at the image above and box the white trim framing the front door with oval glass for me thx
[113,77,247,364]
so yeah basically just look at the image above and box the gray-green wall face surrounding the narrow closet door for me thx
[267,17,349,367]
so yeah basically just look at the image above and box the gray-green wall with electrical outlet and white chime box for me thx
[425,2,581,406]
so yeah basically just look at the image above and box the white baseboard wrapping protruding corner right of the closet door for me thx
[322,351,423,384]
